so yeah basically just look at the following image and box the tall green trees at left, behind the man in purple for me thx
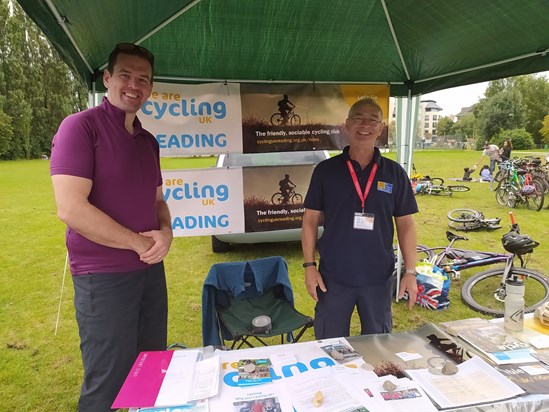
[0,0,88,160]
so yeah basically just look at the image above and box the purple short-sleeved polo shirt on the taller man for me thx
[50,97,162,275]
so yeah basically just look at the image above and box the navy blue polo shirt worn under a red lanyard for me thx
[305,146,418,286]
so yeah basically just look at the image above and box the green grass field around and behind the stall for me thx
[0,151,549,411]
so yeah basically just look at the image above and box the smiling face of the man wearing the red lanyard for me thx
[345,101,383,147]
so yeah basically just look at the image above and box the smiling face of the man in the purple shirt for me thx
[103,53,152,114]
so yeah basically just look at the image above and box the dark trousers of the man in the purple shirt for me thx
[73,263,168,412]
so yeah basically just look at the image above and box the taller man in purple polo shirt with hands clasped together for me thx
[50,43,173,412]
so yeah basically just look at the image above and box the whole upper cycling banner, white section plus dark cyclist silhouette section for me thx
[139,82,389,157]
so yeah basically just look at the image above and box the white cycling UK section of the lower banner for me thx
[162,168,244,237]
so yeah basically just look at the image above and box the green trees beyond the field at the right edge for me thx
[437,74,549,149]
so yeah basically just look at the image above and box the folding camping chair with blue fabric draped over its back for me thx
[202,256,313,349]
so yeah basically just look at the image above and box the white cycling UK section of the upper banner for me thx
[139,83,242,156]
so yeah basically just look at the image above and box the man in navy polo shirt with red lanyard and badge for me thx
[301,99,418,339]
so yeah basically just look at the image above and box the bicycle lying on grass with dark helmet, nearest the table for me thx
[395,213,549,317]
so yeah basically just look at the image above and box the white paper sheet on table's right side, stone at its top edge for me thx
[406,357,525,408]
